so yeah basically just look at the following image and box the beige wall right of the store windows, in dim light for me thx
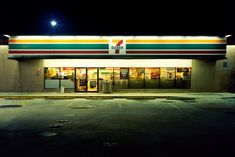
[191,45,235,92]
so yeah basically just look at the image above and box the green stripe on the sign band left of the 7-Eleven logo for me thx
[9,44,109,49]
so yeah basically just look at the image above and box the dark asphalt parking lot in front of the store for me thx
[0,94,235,157]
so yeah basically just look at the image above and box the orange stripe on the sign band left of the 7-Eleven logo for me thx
[9,39,109,43]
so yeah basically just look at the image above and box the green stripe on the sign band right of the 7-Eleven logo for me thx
[126,44,226,49]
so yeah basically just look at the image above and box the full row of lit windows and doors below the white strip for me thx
[44,67,191,91]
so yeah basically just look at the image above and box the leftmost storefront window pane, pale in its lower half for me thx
[44,68,60,88]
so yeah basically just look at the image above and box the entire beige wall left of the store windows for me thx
[0,45,44,92]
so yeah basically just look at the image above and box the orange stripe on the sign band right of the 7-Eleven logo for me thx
[126,39,225,43]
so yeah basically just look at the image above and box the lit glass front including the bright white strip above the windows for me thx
[44,59,192,92]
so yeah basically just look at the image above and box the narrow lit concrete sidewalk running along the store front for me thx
[0,92,235,99]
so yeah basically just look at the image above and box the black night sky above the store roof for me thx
[0,0,235,35]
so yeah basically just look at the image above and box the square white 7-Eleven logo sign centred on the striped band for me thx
[109,39,126,55]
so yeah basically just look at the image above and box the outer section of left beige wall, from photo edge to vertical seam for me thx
[0,45,20,92]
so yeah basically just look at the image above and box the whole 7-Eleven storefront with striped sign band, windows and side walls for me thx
[8,36,226,92]
